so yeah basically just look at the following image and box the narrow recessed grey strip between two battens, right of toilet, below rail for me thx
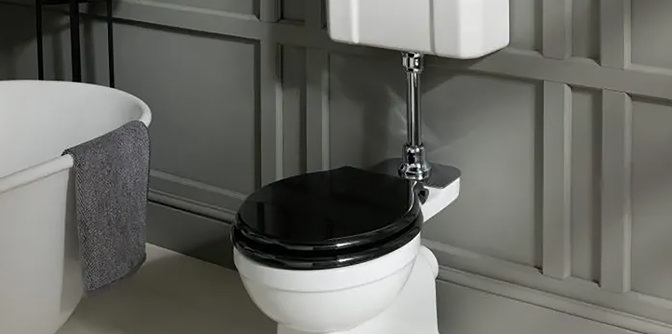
[571,88,602,282]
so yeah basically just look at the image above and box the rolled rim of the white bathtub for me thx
[0,80,152,194]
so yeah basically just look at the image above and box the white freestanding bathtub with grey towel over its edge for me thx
[0,80,151,334]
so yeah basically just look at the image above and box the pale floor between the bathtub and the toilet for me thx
[57,245,275,334]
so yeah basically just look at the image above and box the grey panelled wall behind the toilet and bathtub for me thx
[0,0,672,333]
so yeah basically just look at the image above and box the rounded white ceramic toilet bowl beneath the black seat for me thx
[234,235,420,333]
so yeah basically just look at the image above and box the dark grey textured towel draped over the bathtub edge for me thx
[63,121,149,292]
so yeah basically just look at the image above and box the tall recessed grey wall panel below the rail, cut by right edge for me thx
[632,100,672,299]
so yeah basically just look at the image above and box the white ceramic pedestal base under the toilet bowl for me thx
[277,246,439,334]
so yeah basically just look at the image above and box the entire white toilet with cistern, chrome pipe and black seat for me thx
[231,0,509,334]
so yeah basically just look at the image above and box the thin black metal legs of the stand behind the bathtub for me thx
[35,0,114,87]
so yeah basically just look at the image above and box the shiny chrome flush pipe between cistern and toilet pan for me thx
[399,52,431,181]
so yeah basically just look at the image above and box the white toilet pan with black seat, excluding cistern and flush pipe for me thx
[232,167,459,334]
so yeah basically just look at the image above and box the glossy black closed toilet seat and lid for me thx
[232,167,422,269]
